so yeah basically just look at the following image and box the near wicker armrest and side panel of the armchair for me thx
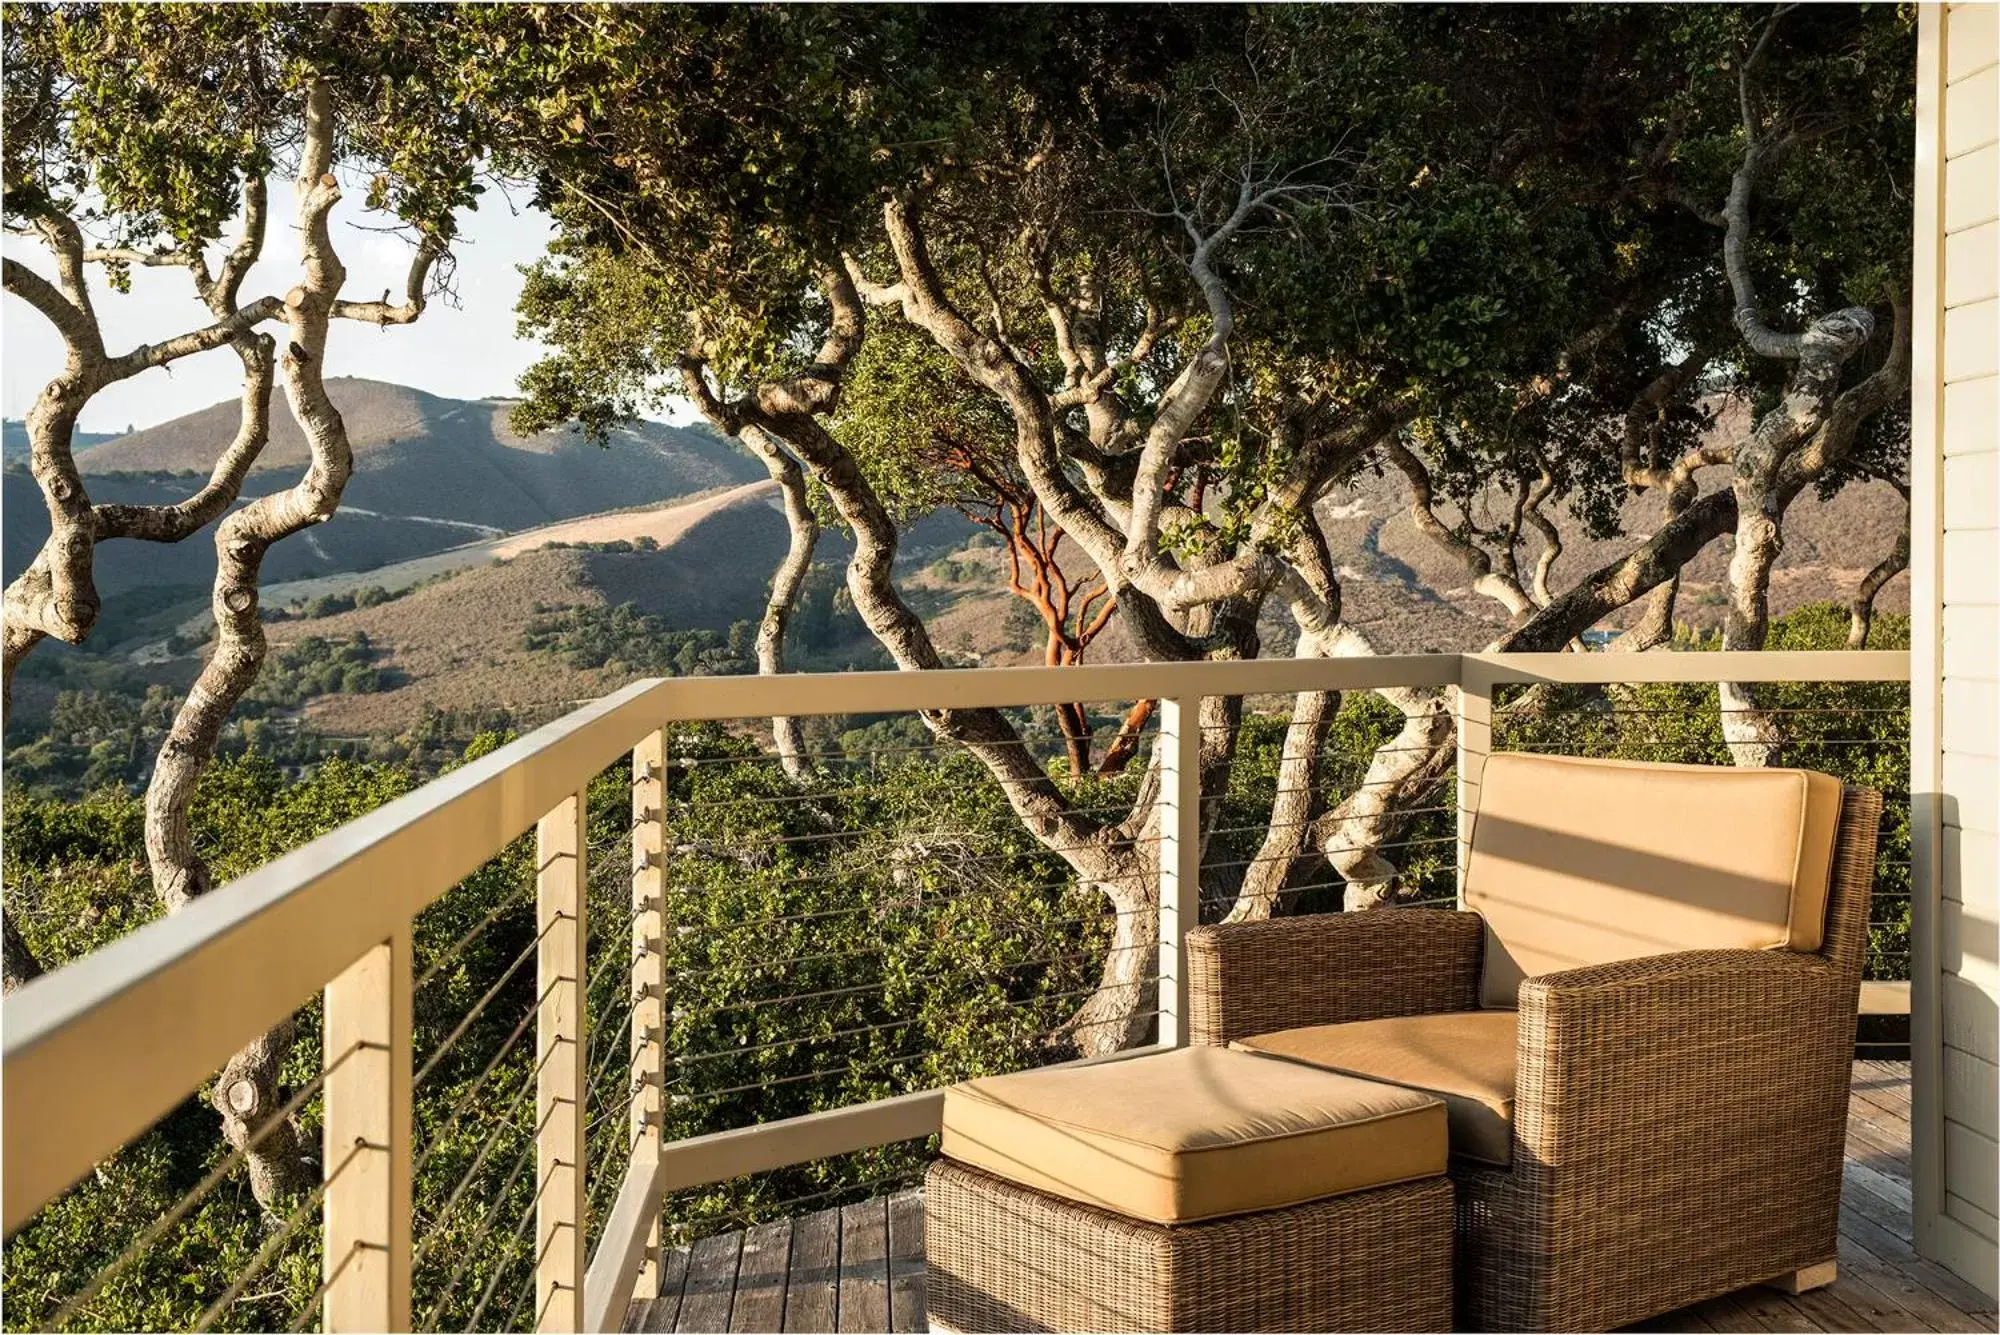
[1454,949,1854,1331]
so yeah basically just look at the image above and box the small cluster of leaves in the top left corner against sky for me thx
[6,4,484,257]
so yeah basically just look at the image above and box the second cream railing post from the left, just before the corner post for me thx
[534,793,588,1331]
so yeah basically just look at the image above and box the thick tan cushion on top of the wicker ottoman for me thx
[940,1047,1446,1223]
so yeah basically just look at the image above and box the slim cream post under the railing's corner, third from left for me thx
[632,727,666,1301]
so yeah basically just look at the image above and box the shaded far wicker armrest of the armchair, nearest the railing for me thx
[1188,909,1484,1045]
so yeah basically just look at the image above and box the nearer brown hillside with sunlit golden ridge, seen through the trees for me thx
[195,443,1908,735]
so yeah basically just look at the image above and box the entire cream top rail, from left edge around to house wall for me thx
[4,652,1910,1233]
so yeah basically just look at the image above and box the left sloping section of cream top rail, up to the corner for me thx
[4,679,660,1233]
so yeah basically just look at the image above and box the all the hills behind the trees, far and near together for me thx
[4,380,1908,735]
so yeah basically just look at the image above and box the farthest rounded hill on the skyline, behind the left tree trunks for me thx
[0,378,764,594]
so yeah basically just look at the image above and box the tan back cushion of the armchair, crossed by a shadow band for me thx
[1466,753,1840,1007]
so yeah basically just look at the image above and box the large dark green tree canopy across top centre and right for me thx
[492,6,1912,619]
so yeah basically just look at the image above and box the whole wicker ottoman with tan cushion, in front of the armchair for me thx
[924,1047,1452,1333]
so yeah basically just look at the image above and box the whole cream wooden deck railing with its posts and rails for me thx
[4,652,1910,1331]
